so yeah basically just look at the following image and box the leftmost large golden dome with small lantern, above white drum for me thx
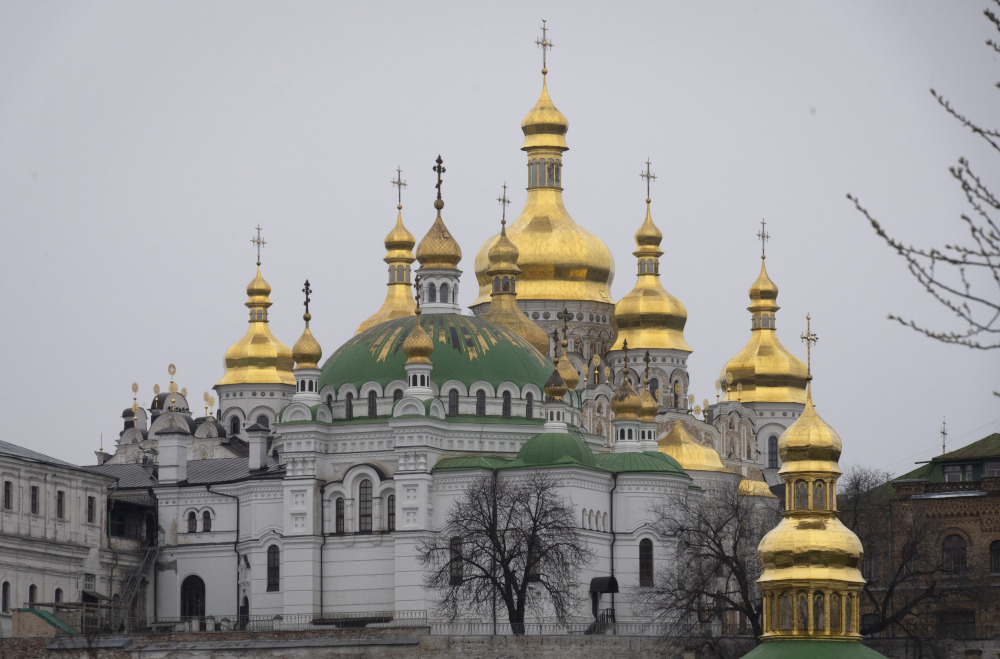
[216,266,295,386]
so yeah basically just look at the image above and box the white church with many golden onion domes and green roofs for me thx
[86,28,820,624]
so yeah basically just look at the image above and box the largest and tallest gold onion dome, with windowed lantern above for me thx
[470,72,615,309]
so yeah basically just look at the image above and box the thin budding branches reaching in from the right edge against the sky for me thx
[847,0,1000,354]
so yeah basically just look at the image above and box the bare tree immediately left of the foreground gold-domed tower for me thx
[641,479,781,656]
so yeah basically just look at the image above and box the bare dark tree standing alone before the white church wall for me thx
[419,471,593,633]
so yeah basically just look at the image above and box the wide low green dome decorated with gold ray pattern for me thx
[319,314,552,398]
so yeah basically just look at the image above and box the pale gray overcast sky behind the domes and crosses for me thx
[0,0,1000,473]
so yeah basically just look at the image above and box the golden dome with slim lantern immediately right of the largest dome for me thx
[611,199,691,352]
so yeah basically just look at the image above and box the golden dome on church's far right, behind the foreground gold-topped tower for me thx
[723,261,807,404]
